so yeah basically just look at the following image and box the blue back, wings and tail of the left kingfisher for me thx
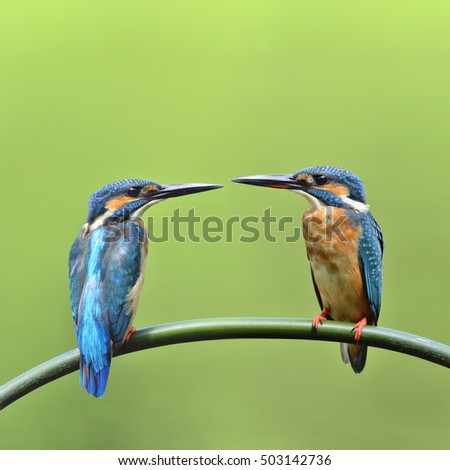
[69,221,146,397]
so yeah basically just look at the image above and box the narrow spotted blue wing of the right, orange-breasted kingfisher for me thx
[358,213,384,324]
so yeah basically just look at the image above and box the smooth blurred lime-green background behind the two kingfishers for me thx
[0,0,450,449]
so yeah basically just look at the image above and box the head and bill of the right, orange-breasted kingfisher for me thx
[233,166,369,212]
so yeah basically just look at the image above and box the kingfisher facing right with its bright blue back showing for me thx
[69,179,222,397]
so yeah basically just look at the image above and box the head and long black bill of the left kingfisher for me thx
[86,179,222,229]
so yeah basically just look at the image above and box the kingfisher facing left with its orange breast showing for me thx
[233,166,384,373]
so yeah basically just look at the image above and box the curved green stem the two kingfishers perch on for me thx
[0,317,450,410]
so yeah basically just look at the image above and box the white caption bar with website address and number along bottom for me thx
[0,450,450,470]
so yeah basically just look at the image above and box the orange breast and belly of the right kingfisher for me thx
[303,206,373,323]
